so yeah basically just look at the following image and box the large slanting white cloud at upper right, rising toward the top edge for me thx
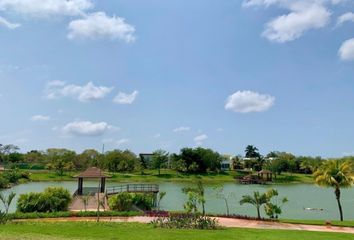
[262,4,331,43]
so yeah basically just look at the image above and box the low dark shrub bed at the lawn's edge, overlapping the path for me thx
[151,213,220,230]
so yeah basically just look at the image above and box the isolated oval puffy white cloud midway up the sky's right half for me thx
[225,91,275,113]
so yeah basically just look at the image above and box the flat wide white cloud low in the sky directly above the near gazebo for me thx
[62,121,116,137]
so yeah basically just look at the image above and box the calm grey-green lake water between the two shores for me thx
[3,181,354,220]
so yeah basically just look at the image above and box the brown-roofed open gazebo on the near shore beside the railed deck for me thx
[75,167,110,196]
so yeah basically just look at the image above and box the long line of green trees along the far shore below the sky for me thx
[0,144,354,175]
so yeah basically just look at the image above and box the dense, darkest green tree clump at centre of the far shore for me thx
[171,147,222,173]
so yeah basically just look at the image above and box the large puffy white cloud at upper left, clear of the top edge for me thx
[68,12,135,43]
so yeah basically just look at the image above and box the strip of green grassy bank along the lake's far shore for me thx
[30,170,313,184]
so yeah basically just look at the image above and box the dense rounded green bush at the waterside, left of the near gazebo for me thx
[17,187,71,212]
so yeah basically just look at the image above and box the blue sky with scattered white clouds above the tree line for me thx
[0,0,354,157]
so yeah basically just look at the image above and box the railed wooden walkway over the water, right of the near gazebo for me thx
[106,184,160,196]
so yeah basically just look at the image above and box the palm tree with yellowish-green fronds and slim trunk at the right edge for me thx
[314,160,354,221]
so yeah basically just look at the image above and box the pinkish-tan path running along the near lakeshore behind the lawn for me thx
[15,216,354,234]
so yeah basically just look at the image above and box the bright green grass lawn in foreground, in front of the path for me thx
[0,222,353,240]
